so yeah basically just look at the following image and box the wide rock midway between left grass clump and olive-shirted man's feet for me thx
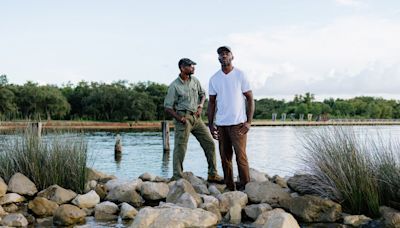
[106,183,144,207]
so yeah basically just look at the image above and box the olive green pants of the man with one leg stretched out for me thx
[173,111,217,179]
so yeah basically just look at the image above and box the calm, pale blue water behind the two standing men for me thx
[85,126,400,179]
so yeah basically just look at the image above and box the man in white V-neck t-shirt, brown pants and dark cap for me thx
[208,46,254,191]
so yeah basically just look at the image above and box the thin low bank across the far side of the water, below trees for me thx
[0,119,400,131]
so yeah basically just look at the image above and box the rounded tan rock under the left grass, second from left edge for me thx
[8,173,37,196]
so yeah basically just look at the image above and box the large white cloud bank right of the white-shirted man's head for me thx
[222,17,400,97]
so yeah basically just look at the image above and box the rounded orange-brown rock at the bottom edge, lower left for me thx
[53,204,86,226]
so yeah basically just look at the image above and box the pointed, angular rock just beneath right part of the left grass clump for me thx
[38,184,77,205]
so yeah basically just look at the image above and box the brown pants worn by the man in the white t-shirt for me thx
[218,124,250,190]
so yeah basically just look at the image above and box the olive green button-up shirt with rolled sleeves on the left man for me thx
[164,76,206,112]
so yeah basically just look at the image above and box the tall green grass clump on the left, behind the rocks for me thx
[0,128,88,193]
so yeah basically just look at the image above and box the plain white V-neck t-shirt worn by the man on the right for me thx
[208,68,251,126]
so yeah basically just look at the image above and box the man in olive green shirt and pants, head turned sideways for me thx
[164,58,223,182]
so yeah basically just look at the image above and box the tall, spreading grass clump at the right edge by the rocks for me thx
[301,126,400,217]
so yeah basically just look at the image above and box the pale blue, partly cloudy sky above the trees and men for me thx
[0,0,400,100]
